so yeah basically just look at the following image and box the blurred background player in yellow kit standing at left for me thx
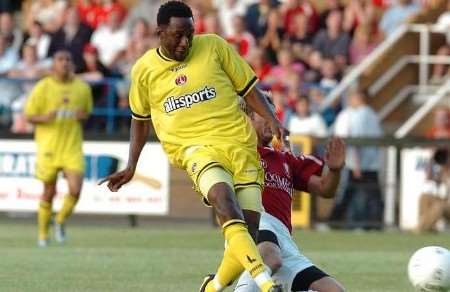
[25,51,92,247]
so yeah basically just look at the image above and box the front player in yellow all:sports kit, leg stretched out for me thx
[100,1,284,292]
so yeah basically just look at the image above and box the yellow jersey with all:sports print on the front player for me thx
[130,34,257,165]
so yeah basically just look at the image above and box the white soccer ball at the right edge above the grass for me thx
[408,246,450,292]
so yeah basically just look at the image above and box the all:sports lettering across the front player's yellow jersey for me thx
[164,86,216,113]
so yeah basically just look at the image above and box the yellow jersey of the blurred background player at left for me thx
[25,77,92,160]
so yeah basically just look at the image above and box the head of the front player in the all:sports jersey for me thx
[157,1,194,61]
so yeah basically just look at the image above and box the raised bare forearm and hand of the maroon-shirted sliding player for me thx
[308,138,345,198]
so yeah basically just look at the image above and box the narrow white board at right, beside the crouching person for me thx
[400,148,432,230]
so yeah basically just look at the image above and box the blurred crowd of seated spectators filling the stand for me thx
[0,0,448,136]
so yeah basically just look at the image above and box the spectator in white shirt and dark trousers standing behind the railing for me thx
[331,89,383,229]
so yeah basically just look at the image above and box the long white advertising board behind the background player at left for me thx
[0,140,169,215]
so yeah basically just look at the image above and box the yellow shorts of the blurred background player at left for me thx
[36,153,84,183]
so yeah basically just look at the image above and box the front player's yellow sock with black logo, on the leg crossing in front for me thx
[222,220,274,292]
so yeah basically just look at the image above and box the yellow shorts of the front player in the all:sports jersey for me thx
[182,144,264,209]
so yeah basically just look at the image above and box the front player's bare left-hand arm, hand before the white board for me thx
[99,119,150,192]
